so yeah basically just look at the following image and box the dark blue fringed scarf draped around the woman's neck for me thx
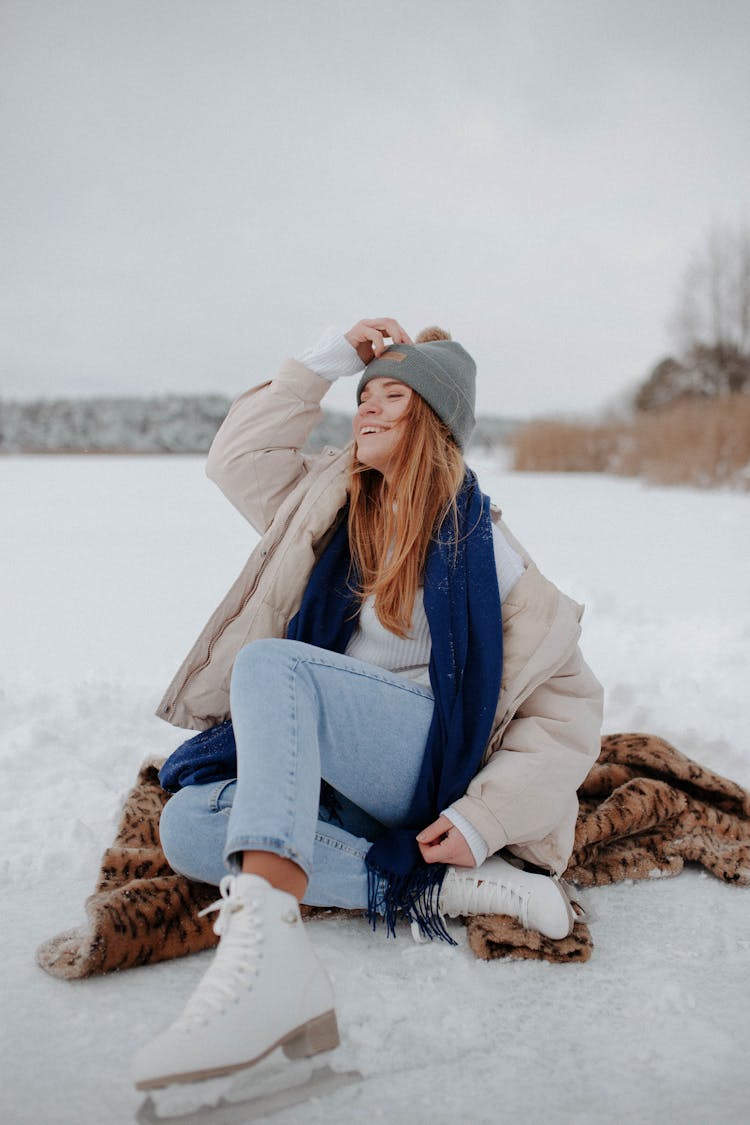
[160,470,503,941]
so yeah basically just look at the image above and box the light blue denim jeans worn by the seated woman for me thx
[160,640,434,909]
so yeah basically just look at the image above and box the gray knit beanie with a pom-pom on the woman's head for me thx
[356,329,477,449]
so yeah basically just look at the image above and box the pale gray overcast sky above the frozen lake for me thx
[0,0,750,415]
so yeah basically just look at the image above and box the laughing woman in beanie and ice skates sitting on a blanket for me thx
[133,318,602,1088]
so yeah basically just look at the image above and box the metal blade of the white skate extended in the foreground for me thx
[135,1047,362,1125]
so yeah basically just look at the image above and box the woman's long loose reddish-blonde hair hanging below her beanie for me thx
[349,389,466,637]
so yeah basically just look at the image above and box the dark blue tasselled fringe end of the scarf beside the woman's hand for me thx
[368,863,458,945]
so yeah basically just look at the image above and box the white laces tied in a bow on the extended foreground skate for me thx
[175,875,263,1029]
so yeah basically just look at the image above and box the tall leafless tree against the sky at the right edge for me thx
[674,225,750,359]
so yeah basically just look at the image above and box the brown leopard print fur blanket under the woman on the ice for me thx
[37,735,750,980]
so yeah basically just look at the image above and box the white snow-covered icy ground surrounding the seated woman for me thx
[0,457,750,1125]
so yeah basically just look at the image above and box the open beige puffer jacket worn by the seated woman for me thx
[156,360,603,872]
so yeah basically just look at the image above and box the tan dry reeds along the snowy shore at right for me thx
[510,394,750,488]
